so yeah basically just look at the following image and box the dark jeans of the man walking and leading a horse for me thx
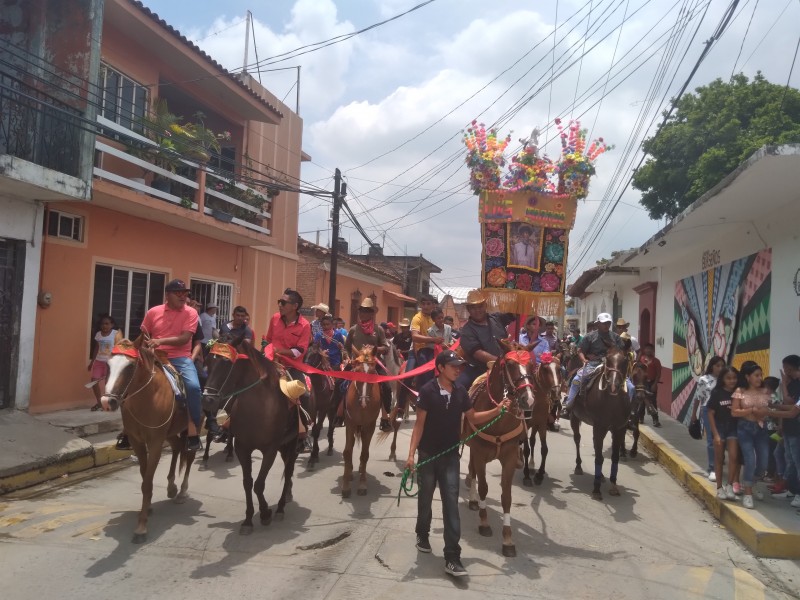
[415,451,460,560]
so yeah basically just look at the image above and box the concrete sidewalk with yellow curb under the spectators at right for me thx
[639,414,800,559]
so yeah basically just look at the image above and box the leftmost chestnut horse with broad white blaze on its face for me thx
[102,335,195,544]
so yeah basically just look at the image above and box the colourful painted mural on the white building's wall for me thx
[671,248,772,423]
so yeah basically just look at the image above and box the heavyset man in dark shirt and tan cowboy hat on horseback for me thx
[458,290,514,389]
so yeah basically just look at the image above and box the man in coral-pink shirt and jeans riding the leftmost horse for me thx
[141,279,203,451]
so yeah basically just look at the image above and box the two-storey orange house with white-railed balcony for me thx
[16,0,304,412]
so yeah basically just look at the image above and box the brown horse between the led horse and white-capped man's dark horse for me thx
[522,353,561,485]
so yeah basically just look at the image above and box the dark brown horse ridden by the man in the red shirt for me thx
[203,336,297,535]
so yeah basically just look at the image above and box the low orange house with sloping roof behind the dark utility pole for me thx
[297,238,417,327]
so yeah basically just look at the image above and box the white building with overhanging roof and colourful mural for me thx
[571,145,800,421]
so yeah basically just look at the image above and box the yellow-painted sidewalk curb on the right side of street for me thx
[639,426,800,559]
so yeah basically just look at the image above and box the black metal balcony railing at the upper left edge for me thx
[0,71,85,177]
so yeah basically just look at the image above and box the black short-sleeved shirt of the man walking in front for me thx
[417,378,472,456]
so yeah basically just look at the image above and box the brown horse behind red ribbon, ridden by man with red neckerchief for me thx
[342,345,381,498]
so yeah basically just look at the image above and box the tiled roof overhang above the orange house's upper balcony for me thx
[103,0,283,125]
